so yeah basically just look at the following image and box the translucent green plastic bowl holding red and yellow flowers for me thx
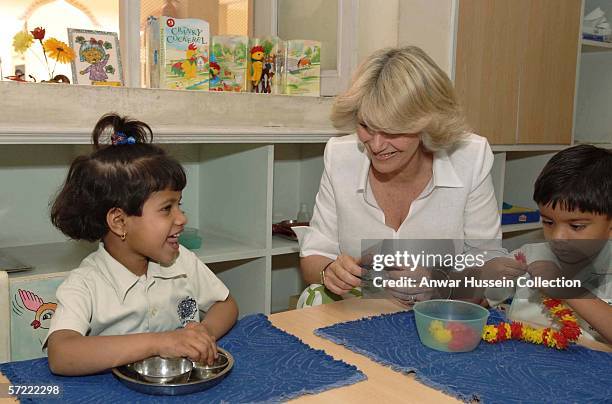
[413,300,489,352]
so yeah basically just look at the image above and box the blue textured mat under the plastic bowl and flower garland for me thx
[315,312,612,403]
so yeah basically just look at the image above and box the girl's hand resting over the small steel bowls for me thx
[157,323,217,365]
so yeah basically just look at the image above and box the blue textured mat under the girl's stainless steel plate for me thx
[0,314,366,403]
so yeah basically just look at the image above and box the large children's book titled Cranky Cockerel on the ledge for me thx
[146,16,209,90]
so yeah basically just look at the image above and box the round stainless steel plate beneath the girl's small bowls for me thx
[113,348,234,396]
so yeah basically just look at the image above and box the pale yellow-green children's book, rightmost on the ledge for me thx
[284,39,321,97]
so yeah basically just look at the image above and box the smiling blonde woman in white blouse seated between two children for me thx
[294,46,520,306]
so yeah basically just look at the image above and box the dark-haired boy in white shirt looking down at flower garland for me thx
[486,145,612,342]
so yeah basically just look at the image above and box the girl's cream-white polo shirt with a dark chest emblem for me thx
[43,243,229,346]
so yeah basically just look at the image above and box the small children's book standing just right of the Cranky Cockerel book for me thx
[208,35,249,92]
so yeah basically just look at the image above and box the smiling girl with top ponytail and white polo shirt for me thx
[45,114,238,375]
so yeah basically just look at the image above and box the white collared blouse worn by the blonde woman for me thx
[294,134,503,259]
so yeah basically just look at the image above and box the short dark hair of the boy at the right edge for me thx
[533,145,612,217]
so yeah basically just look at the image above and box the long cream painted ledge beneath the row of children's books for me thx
[0,81,342,144]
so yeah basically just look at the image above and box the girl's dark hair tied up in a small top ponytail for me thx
[51,114,187,241]
